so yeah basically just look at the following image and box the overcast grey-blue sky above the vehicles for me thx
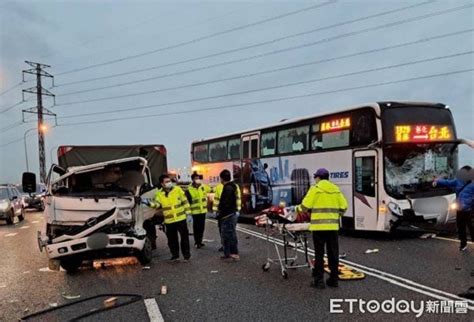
[0,0,474,182]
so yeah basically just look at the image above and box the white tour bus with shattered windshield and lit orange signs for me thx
[191,102,460,231]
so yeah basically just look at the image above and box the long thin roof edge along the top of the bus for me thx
[192,101,446,144]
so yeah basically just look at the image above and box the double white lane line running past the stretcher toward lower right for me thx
[233,227,474,311]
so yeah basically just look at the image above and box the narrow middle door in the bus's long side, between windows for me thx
[240,132,265,213]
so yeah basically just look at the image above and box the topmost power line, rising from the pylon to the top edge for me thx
[57,1,336,76]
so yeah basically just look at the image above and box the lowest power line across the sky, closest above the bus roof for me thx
[54,68,474,126]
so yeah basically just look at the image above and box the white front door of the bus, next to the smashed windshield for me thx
[352,150,379,230]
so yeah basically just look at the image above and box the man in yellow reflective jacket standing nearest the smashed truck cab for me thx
[150,174,191,261]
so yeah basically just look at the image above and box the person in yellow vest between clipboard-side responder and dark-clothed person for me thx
[186,172,211,248]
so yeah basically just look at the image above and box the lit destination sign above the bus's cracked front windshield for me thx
[395,124,453,142]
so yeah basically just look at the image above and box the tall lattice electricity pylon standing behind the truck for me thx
[22,61,57,183]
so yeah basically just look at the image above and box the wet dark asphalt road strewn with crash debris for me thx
[0,212,474,321]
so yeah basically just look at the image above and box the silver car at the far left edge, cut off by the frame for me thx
[0,184,25,225]
